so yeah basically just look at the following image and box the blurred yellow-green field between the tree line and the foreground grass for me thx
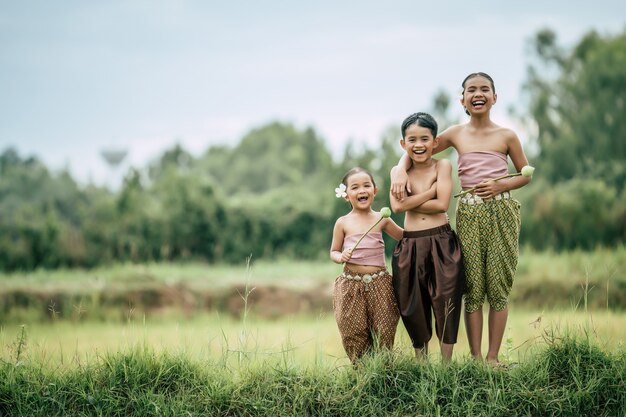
[0,247,626,365]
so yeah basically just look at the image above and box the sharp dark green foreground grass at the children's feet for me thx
[0,333,626,417]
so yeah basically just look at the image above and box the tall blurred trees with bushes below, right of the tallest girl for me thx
[519,29,626,249]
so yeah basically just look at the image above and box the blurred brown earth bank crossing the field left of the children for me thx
[0,282,332,320]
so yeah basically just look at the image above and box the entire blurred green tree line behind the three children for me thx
[0,29,626,271]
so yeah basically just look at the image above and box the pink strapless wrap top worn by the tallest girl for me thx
[459,151,509,189]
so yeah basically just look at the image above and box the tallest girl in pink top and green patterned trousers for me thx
[391,72,530,364]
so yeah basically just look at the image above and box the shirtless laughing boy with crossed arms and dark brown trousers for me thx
[390,113,465,361]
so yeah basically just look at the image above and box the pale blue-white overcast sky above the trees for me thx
[0,0,626,184]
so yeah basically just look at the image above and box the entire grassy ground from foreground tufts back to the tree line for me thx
[0,248,626,417]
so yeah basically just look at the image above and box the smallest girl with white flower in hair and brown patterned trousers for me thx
[330,167,402,363]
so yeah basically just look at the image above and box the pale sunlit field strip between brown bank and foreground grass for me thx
[0,309,626,367]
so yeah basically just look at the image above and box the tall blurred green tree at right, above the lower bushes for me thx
[525,29,626,188]
